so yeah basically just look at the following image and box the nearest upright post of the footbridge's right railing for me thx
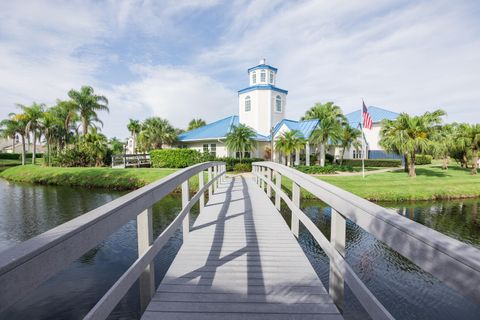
[328,208,346,310]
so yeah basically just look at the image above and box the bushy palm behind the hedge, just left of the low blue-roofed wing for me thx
[139,117,177,150]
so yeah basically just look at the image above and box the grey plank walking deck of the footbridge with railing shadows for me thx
[142,176,343,320]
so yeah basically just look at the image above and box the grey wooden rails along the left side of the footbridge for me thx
[0,161,226,319]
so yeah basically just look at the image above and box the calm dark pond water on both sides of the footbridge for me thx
[0,180,480,319]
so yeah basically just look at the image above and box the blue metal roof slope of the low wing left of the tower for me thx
[178,116,270,142]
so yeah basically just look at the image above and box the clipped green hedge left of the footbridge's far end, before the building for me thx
[150,149,207,168]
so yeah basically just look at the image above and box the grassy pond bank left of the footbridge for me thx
[0,165,183,190]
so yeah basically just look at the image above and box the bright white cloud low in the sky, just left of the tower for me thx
[105,65,237,139]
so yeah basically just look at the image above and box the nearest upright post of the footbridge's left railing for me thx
[137,208,155,312]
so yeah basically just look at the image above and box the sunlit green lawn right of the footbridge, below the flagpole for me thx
[317,166,480,201]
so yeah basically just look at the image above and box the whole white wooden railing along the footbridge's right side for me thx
[252,162,480,319]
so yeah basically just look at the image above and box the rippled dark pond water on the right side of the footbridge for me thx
[282,200,480,320]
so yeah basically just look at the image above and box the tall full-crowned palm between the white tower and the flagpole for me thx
[302,102,346,167]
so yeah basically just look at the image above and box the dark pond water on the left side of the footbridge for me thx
[0,180,198,319]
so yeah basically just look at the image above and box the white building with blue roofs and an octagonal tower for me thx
[178,59,398,165]
